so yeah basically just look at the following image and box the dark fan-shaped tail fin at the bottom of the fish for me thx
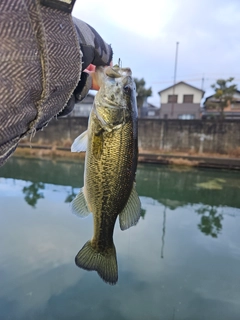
[75,241,118,285]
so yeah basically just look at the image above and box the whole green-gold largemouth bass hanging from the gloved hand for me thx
[71,65,141,285]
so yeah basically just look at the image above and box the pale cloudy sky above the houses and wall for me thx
[73,0,240,107]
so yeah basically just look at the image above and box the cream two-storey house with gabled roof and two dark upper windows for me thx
[158,81,204,120]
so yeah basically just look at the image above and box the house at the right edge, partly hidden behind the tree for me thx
[202,90,240,119]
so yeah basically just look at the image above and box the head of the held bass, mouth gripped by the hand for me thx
[94,65,137,131]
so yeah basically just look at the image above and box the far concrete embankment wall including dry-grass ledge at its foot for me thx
[17,117,240,170]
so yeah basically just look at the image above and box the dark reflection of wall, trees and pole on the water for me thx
[0,158,240,240]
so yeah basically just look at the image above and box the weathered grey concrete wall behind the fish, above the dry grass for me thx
[32,117,240,154]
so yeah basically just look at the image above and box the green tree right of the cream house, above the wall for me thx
[206,78,237,118]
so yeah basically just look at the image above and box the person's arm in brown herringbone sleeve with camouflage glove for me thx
[0,0,112,166]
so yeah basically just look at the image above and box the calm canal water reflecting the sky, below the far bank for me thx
[0,158,240,320]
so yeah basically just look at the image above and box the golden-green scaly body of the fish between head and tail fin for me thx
[85,121,135,249]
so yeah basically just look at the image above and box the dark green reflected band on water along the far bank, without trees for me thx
[0,158,240,210]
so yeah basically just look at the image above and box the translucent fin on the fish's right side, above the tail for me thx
[119,186,141,230]
